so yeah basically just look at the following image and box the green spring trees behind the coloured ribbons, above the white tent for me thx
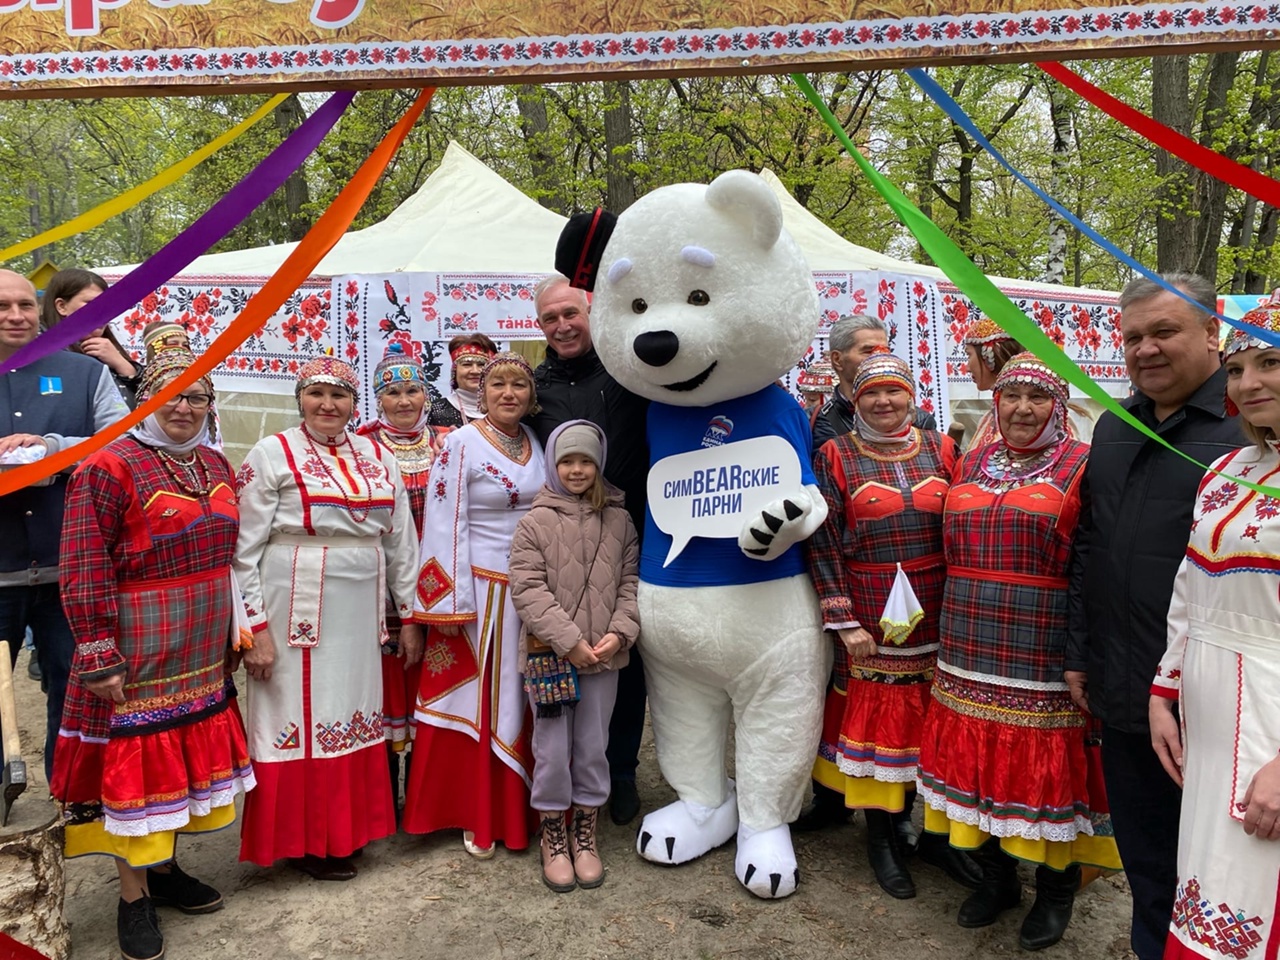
[0,59,1280,292]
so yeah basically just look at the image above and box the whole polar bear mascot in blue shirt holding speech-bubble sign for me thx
[557,170,832,897]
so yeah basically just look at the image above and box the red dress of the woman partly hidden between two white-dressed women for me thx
[357,420,442,750]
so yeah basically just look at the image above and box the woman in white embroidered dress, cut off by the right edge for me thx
[1151,307,1280,960]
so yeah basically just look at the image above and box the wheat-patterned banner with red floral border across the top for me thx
[0,0,1280,97]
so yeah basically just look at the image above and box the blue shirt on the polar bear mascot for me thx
[640,384,818,586]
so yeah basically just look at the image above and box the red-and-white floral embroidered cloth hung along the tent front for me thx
[108,271,1129,429]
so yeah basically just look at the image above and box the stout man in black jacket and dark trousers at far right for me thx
[1065,274,1244,960]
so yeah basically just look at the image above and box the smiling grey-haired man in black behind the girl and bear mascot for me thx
[529,274,649,823]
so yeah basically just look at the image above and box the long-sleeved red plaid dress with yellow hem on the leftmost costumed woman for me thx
[50,438,253,867]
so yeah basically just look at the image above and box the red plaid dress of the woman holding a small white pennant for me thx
[809,430,956,812]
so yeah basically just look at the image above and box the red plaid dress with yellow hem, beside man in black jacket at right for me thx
[919,439,1120,869]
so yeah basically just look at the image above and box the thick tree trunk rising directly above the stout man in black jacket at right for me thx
[1151,55,1198,274]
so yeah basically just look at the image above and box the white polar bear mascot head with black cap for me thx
[557,170,819,407]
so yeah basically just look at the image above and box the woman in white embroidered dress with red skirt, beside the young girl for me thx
[403,353,545,859]
